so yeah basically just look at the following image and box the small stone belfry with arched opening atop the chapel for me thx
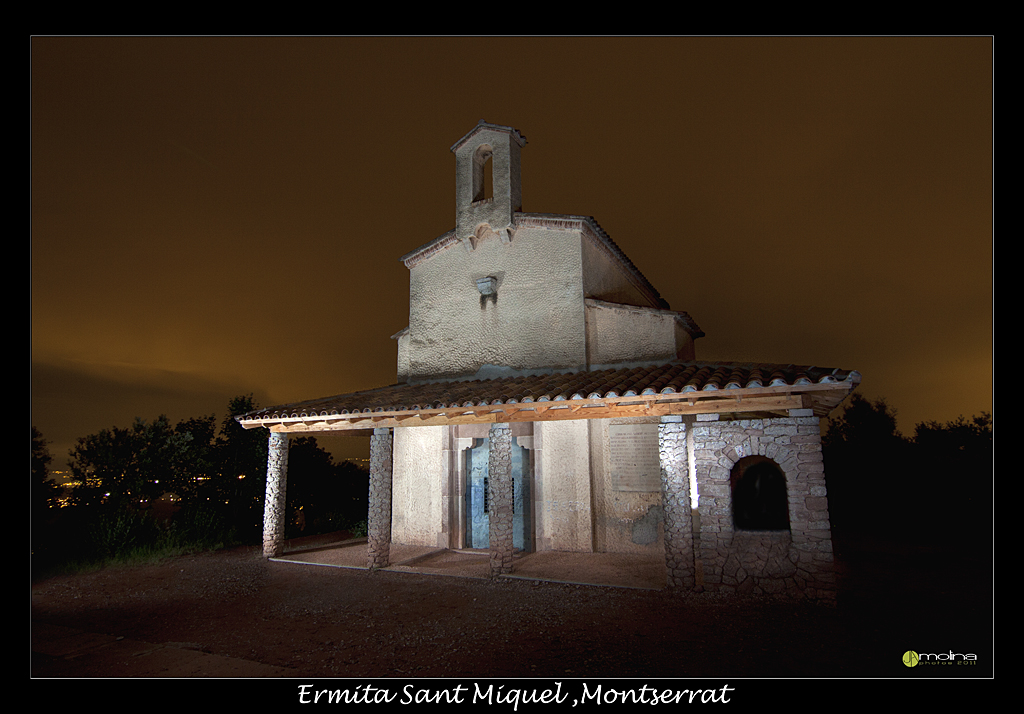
[452,119,526,251]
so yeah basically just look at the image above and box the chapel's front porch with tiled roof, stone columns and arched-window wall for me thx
[238,363,860,596]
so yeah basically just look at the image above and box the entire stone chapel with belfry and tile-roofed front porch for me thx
[239,121,860,599]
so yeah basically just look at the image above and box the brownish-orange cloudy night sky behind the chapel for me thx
[31,37,993,468]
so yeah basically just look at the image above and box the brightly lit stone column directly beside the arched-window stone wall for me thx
[657,417,696,590]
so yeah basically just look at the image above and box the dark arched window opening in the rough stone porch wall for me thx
[729,456,790,531]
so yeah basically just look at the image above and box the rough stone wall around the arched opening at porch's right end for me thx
[692,415,836,600]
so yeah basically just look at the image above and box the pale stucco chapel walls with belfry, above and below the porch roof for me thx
[392,123,702,552]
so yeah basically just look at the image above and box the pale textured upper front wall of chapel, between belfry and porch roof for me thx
[399,229,586,380]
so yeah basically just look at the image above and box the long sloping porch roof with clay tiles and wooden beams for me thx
[236,363,860,435]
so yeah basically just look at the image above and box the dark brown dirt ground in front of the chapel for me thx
[31,528,993,679]
